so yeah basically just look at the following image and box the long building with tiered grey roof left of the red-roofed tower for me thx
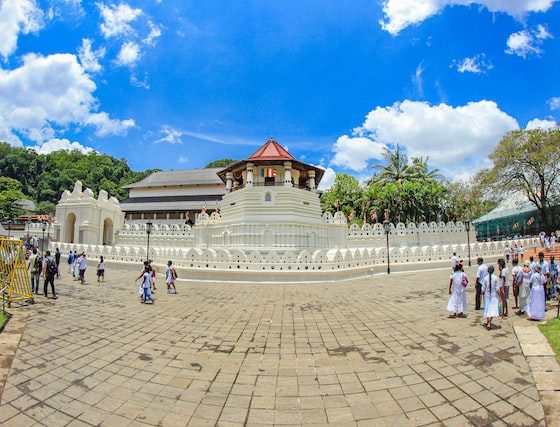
[121,168,226,223]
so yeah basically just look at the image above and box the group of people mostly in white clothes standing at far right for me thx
[447,252,559,330]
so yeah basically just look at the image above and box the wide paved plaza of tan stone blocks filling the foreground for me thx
[0,267,544,427]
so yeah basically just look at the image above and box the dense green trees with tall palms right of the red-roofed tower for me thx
[321,146,495,223]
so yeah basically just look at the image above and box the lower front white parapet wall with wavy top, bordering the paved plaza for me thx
[51,238,538,282]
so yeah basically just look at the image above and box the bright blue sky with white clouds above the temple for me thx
[0,0,560,189]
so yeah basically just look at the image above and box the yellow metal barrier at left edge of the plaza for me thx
[0,237,34,306]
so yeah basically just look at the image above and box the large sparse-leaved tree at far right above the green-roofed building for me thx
[484,127,560,228]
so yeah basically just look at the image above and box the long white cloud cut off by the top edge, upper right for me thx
[380,0,556,36]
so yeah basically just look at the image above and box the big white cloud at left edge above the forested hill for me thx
[0,54,134,143]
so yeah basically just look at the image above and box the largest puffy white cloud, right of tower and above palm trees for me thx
[332,100,519,176]
